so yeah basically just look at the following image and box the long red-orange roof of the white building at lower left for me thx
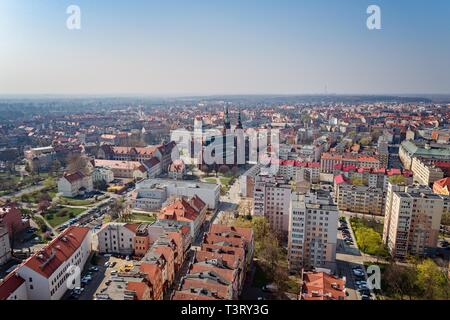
[23,226,90,278]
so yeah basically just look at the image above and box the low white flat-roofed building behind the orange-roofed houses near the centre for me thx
[133,179,220,211]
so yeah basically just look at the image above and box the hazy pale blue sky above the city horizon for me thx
[0,0,450,95]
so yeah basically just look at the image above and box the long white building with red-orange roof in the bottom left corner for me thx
[0,227,91,300]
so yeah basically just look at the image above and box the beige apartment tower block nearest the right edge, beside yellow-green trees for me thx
[383,184,444,259]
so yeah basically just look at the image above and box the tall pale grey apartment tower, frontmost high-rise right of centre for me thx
[288,190,339,272]
